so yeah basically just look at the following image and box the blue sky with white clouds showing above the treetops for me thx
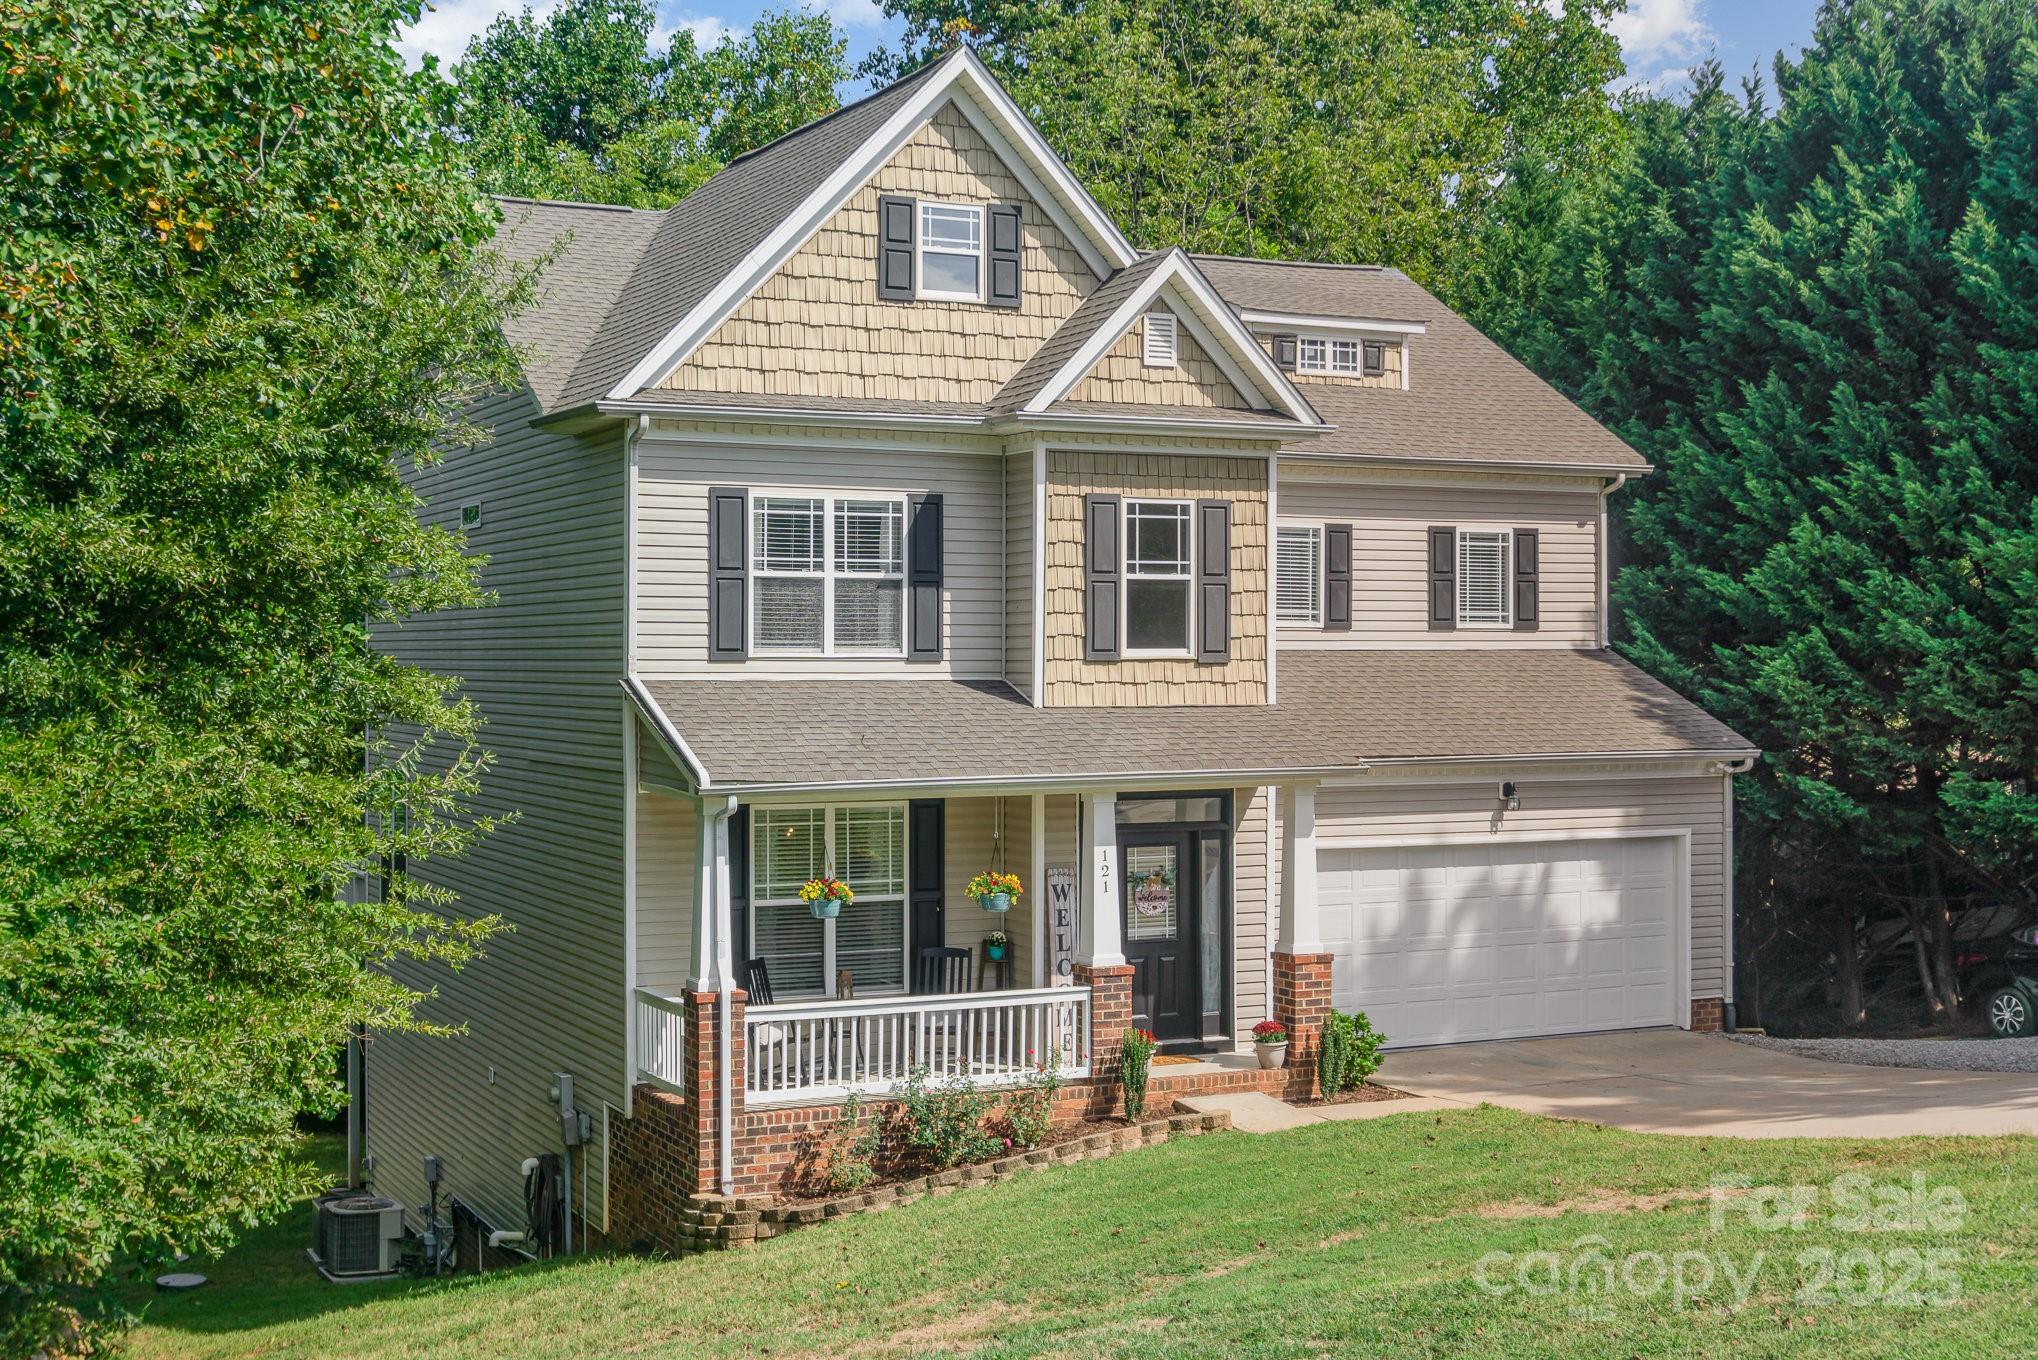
[404,0,1818,94]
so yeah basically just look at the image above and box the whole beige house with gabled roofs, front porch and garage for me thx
[365,51,1753,1264]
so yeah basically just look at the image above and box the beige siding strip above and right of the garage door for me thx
[1317,775,1726,997]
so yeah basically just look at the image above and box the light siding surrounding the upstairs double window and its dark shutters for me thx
[636,436,1007,679]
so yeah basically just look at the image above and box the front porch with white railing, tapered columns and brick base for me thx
[613,770,1329,1199]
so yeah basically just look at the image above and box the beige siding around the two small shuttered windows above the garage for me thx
[1280,463,1600,648]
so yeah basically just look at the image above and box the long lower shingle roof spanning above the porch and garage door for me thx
[644,648,1753,789]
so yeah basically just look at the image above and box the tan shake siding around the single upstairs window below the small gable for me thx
[1043,449,1268,708]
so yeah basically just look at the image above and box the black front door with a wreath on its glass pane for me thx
[1119,826,1202,1044]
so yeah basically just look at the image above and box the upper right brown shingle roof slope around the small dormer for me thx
[1194,255,1647,469]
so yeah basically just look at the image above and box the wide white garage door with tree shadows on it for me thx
[1317,838,1677,1046]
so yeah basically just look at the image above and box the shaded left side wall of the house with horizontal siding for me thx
[367,394,626,1230]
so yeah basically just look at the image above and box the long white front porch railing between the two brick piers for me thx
[744,987,1090,1105]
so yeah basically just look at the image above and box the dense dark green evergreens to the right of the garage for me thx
[1482,0,2038,1022]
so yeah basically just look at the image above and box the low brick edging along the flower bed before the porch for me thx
[654,1111,1231,1254]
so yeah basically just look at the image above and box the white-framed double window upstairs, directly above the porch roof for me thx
[750,495,905,657]
